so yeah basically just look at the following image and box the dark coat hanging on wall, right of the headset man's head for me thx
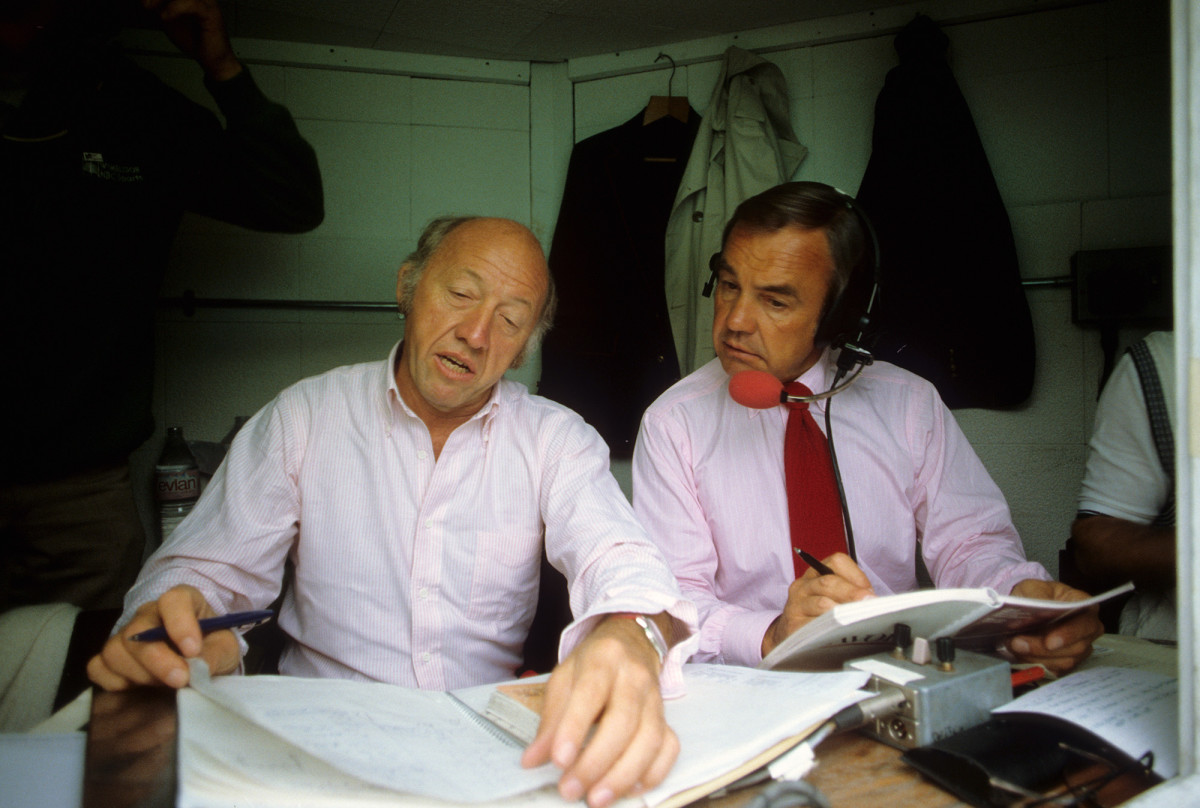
[858,17,1034,408]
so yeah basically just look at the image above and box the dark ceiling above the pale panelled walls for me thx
[196,0,898,61]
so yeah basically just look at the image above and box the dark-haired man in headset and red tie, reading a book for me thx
[632,182,1103,672]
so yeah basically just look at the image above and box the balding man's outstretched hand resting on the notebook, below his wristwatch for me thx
[521,617,679,808]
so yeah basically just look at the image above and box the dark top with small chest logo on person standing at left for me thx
[0,36,324,481]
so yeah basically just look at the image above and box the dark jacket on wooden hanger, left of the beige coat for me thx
[538,110,700,457]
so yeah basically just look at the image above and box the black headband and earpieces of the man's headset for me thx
[702,188,881,372]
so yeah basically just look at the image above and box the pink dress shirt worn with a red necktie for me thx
[634,352,1050,665]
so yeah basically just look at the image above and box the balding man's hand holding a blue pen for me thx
[88,586,241,690]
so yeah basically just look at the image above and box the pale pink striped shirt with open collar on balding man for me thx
[120,346,696,694]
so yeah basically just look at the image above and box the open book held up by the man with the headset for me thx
[760,583,1133,670]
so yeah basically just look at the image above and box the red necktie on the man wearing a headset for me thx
[784,382,846,577]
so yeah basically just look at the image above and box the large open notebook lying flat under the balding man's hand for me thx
[178,663,869,808]
